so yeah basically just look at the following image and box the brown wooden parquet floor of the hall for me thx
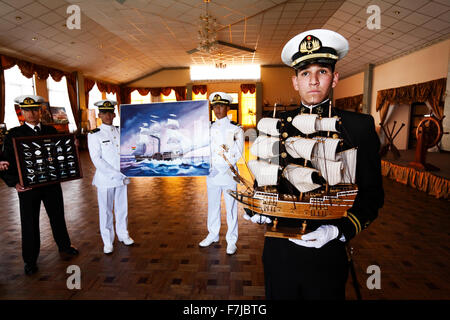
[0,151,450,300]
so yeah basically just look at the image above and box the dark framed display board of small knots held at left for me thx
[13,134,83,188]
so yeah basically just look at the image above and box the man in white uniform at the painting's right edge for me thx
[199,92,244,255]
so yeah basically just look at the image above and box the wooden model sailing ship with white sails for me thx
[228,110,358,232]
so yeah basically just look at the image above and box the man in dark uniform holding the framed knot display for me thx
[1,95,78,275]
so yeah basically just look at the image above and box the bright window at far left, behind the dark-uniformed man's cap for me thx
[4,66,36,129]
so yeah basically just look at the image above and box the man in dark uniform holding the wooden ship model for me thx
[252,29,384,300]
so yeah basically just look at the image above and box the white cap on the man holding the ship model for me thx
[281,29,348,69]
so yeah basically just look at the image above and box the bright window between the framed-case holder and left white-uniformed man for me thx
[47,76,77,132]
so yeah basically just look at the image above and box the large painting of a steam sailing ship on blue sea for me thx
[120,100,210,177]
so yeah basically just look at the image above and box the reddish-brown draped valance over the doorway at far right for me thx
[376,78,447,123]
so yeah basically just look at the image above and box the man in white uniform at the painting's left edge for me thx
[88,100,134,254]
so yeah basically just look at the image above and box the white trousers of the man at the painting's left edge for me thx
[97,185,128,246]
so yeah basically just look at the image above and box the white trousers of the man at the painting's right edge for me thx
[207,181,238,244]
